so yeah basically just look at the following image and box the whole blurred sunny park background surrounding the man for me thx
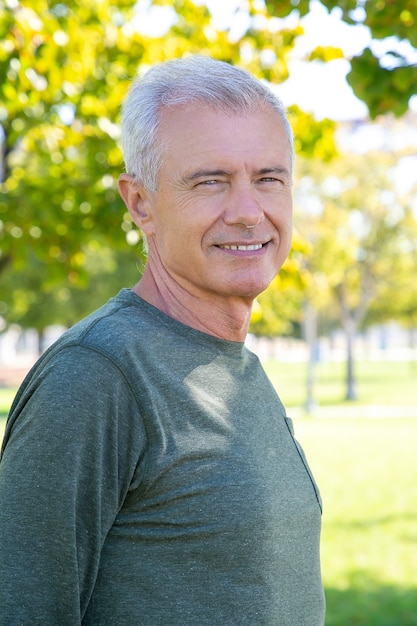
[0,0,417,626]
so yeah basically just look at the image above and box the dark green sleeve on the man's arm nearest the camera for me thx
[0,346,146,626]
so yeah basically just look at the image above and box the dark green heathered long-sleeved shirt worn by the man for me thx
[0,290,324,626]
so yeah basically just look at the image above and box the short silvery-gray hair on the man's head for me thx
[122,55,294,191]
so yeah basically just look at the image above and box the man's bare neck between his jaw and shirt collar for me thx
[133,265,253,342]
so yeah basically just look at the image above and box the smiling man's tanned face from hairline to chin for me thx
[138,105,292,301]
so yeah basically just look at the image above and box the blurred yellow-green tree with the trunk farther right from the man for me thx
[296,153,416,400]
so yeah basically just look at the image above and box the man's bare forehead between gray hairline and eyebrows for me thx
[158,103,291,169]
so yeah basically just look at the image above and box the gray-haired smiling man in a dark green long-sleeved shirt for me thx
[0,56,324,626]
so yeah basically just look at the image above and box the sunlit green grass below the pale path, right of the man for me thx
[295,418,417,626]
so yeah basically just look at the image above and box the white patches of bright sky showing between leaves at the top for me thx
[137,0,417,121]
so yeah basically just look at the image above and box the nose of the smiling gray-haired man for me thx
[223,183,265,228]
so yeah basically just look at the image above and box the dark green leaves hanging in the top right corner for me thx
[266,0,417,119]
